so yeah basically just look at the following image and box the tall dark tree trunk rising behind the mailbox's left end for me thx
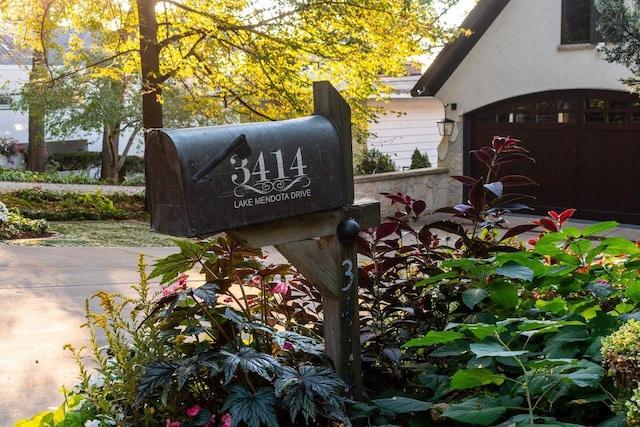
[137,0,163,130]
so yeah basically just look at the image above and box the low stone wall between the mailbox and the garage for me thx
[354,167,462,216]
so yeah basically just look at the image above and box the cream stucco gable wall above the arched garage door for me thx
[436,0,629,118]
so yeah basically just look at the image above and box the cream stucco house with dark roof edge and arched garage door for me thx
[411,0,640,223]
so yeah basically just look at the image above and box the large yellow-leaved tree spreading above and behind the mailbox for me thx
[1,0,457,176]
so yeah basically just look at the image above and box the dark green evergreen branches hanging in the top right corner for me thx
[596,0,640,92]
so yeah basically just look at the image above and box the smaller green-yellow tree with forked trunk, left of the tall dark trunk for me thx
[49,0,142,183]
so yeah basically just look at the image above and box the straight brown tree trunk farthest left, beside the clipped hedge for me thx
[26,50,47,172]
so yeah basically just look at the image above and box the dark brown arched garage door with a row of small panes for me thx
[464,90,640,224]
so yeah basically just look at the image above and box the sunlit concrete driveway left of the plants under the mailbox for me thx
[0,245,178,426]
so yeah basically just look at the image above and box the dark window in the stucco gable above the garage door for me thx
[560,0,604,44]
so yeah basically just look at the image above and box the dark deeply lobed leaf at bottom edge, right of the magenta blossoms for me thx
[222,385,279,427]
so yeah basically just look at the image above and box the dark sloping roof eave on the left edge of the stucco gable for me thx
[411,0,509,96]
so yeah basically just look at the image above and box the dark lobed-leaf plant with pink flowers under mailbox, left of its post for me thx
[136,238,348,426]
